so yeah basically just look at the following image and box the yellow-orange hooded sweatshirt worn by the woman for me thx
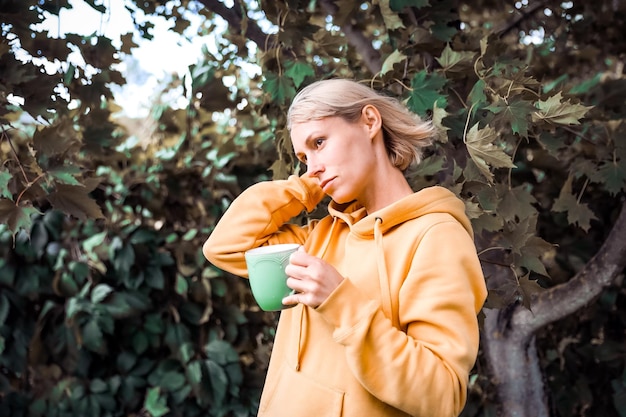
[203,176,487,417]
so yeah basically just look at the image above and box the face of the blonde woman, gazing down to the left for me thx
[291,111,380,203]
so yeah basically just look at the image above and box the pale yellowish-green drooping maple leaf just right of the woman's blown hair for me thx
[464,123,515,183]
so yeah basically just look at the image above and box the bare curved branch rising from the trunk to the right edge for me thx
[511,203,626,337]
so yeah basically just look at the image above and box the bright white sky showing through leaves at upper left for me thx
[37,0,217,117]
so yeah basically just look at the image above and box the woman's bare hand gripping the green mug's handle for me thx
[283,247,344,308]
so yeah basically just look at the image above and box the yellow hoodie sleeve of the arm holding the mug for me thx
[318,220,487,417]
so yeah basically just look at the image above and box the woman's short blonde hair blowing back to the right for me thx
[287,79,435,171]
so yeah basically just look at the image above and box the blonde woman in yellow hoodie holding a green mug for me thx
[203,79,486,417]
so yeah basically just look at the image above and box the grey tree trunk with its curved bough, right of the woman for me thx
[481,204,626,417]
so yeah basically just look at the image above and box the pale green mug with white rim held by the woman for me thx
[245,243,300,311]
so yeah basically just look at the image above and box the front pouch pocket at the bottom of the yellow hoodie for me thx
[258,363,344,417]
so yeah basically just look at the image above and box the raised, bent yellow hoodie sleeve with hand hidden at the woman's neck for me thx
[202,175,324,277]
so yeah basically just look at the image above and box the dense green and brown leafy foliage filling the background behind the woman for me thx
[0,0,626,416]
